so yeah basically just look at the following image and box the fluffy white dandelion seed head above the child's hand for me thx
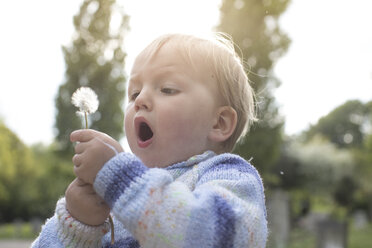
[71,87,99,114]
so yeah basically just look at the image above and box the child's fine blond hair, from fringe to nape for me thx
[141,33,256,151]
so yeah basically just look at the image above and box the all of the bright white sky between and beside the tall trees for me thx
[0,0,372,144]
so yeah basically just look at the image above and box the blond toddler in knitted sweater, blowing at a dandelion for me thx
[33,34,268,248]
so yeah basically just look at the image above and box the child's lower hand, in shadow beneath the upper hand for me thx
[65,178,110,226]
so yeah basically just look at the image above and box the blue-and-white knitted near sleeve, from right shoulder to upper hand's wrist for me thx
[94,153,267,248]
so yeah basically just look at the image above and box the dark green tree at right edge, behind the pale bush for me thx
[304,100,372,211]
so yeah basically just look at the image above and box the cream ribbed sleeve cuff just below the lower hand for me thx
[56,198,110,247]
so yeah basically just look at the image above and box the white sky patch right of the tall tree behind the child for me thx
[275,0,372,134]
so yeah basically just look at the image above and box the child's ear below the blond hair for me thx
[208,106,238,142]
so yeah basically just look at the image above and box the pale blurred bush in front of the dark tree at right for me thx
[276,136,360,213]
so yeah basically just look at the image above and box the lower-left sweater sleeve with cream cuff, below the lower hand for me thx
[32,198,110,248]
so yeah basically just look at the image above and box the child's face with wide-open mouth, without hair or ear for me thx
[125,44,221,167]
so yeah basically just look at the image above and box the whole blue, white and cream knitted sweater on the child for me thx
[32,151,268,248]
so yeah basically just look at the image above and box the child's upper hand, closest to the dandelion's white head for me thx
[70,129,123,184]
